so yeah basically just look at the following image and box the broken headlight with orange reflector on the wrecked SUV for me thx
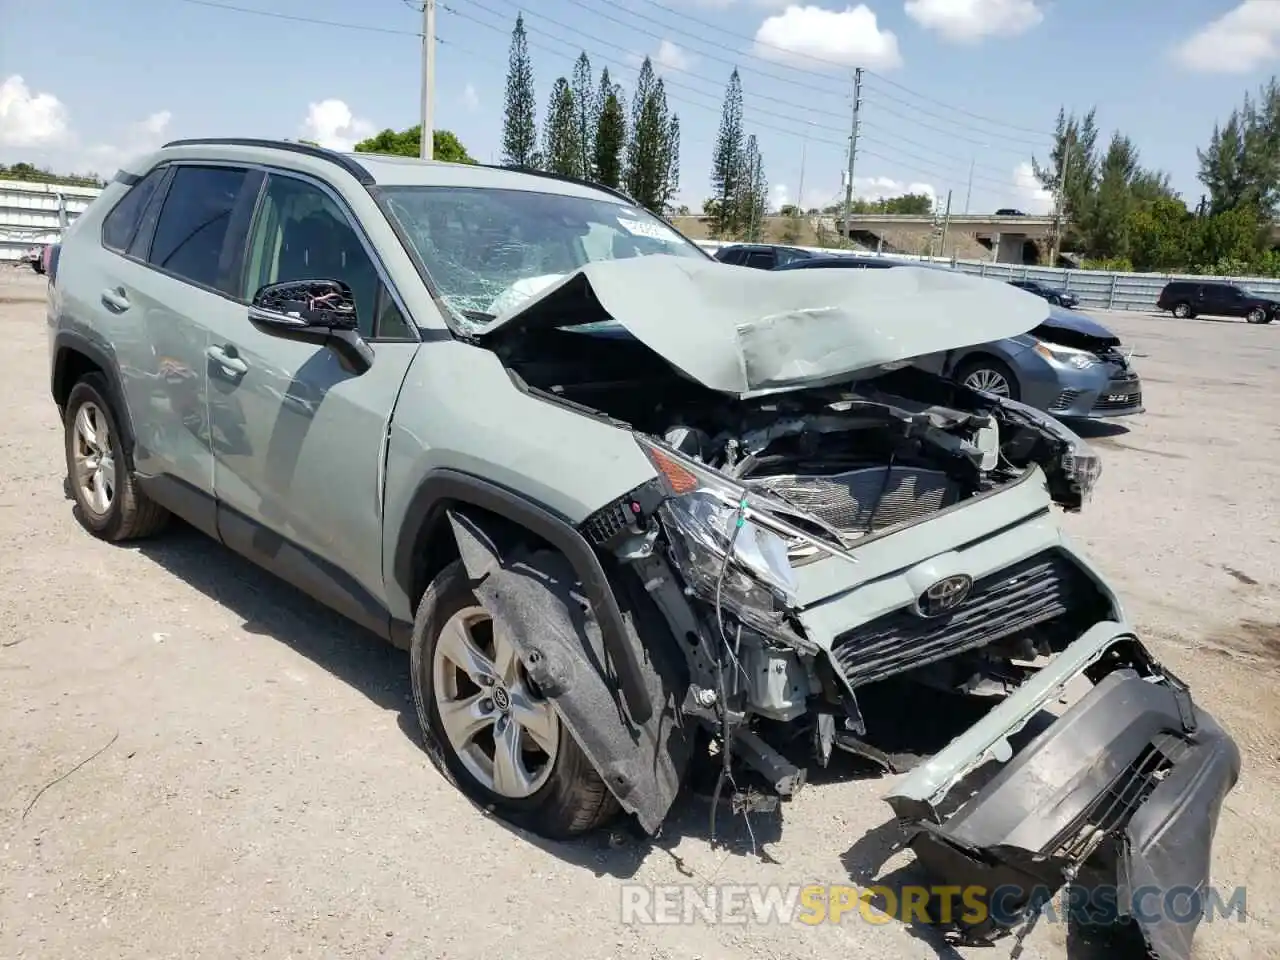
[636,436,796,640]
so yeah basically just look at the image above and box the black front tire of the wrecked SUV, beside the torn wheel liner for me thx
[410,561,618,840]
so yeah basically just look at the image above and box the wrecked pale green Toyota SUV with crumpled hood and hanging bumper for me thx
[49,140,1239,959]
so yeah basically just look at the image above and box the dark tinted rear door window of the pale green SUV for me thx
[147,166,248,288]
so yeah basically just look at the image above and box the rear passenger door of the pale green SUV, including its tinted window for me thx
[92,163,261,534]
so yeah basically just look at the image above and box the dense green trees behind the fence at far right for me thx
[1032,77,1280,276]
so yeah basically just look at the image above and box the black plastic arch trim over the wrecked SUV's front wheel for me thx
[393,468,653,723]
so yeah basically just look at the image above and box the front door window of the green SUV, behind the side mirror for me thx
[242,175,411,338]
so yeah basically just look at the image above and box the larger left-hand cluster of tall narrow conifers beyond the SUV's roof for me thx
[502,14,680,214]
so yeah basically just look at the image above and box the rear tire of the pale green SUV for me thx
[63,374,169,543]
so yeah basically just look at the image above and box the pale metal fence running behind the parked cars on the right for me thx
[698,241,1280,311]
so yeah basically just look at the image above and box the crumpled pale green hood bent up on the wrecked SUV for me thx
[474,255,1044,397]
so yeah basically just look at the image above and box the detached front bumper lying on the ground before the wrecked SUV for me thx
[887,623,1240,960]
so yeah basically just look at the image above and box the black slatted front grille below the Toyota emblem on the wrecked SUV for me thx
[832,550,1107,687]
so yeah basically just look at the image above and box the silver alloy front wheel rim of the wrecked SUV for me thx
[431,607,561,800]
